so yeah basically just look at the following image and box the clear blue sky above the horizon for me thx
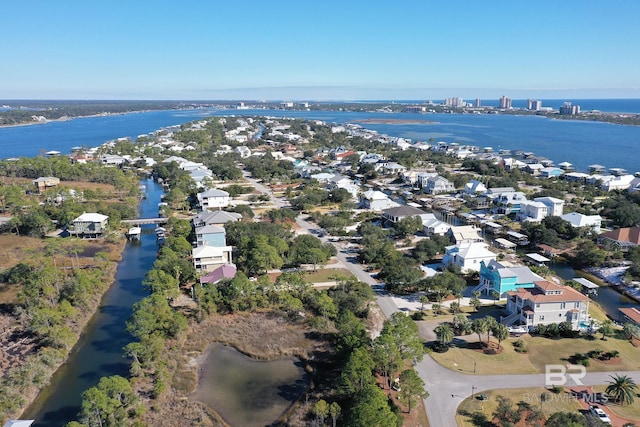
[0,0,640,100]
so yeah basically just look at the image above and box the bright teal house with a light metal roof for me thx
[473,261,545,297]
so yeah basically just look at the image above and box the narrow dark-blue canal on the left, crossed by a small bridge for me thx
[22,180,162,427]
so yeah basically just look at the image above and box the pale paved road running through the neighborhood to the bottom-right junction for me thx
[245,174,640,427]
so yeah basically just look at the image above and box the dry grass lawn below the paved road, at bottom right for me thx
[456,387,582,427]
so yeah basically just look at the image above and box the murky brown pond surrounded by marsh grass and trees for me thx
[190,344,308,427]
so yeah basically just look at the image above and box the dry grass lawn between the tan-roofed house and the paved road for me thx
[432,334,640,375]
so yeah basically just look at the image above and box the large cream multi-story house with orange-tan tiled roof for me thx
[500,280,589,330]
